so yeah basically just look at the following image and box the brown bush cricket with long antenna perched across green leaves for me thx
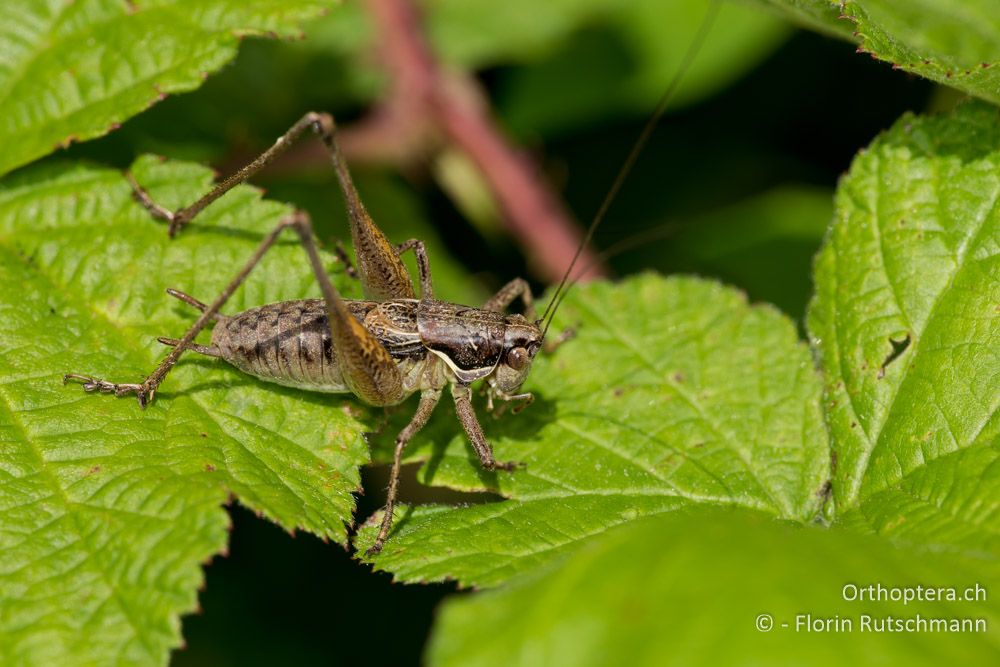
[63,2,719,555]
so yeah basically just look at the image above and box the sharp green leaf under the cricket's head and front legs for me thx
[357,275,828,586]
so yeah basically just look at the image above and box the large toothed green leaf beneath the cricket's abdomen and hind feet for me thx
[0,159,370,664]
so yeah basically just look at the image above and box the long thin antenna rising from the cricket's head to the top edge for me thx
[539,0,722,338]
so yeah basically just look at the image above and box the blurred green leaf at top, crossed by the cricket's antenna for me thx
[492,0,788,135]
